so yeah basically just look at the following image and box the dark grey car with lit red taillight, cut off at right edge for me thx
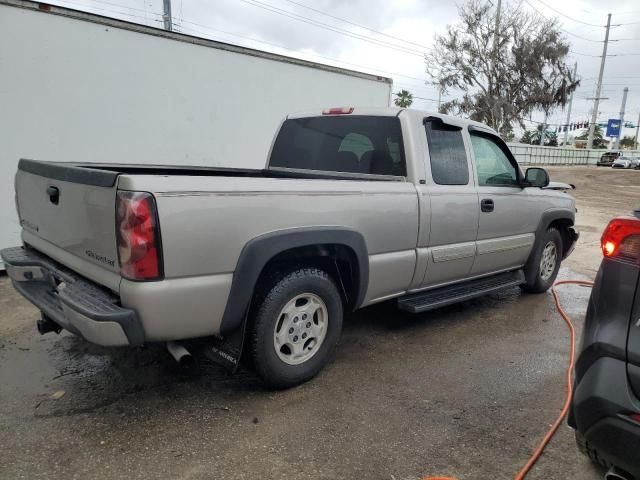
[569,211,640,480]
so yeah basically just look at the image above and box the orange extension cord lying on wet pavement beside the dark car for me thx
[423,280,593,480]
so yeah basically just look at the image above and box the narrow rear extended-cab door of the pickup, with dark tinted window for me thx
[418,117,479,288]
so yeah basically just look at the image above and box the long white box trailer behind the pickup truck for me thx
[0,0,392,269]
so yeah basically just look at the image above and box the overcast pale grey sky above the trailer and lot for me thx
[51,0,640,137]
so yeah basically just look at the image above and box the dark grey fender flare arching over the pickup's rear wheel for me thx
[220,227,369,336]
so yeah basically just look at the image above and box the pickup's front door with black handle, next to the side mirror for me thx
[469,130,540,276]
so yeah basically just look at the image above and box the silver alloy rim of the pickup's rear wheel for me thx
[273,293,329,365]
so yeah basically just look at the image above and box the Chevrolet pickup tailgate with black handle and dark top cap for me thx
[15,160,119,277]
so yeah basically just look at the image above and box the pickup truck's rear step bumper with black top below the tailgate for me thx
[0,247,145,346]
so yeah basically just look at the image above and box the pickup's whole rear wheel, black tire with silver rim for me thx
[251,268,342,388]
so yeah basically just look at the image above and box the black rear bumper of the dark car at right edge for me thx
[569,357,640,478]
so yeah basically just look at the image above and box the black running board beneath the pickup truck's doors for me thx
[398,270,525,313]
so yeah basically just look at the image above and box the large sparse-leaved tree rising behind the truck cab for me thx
[425,0,579,136]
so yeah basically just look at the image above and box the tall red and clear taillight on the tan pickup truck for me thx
[116,191,162,280]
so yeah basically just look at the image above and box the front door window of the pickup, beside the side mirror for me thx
[471,133,518,186]
